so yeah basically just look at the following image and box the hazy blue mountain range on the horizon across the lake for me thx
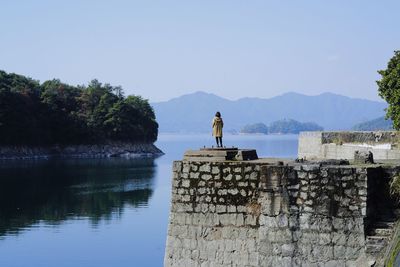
[152,92,387,133]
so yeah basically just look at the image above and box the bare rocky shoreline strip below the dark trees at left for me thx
[0,143,164,160]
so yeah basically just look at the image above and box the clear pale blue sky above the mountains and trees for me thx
[0,0,400,102]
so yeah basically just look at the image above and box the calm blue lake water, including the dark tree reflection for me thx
[0,135,298,267]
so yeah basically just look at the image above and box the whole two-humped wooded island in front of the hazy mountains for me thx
[240,119,323,134]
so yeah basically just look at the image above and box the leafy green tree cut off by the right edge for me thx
[377,51,400,130]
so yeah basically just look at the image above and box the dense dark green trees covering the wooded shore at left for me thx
[0,71,158,145]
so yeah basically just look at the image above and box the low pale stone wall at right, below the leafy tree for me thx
[298,131,400,160]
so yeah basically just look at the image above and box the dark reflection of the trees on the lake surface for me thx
[0,159,155,236]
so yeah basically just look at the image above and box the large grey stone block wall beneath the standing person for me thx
[164,160,376,267]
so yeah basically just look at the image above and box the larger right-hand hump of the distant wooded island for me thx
[269,119,323,134]
